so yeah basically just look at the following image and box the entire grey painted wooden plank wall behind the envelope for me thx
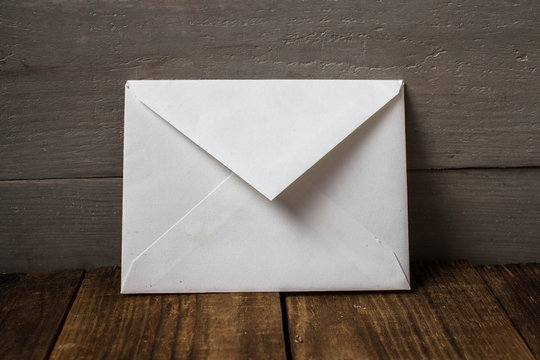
[0,0,540,271]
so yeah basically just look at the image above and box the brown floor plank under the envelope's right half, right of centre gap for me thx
[286,263,533,359]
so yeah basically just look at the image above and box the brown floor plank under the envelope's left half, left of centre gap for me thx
[51,268,285,359]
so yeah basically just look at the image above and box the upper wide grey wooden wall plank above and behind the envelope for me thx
[0,0,540,179]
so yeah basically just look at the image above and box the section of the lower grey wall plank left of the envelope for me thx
[0,179,122,272]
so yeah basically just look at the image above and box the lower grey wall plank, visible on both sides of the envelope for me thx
[0,169,540,272]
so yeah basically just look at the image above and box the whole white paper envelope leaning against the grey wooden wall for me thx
[121,80,410,293]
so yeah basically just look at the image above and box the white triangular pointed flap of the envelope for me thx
[127,80,402,200]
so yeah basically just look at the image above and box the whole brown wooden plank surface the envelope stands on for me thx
[0,262,540,359]
